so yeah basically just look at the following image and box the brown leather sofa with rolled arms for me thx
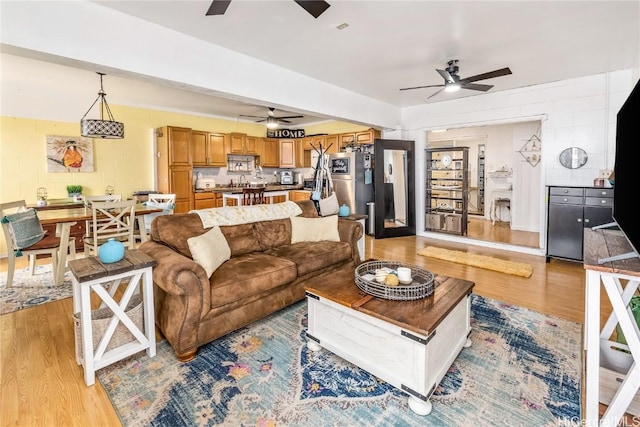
[140,201,363,362]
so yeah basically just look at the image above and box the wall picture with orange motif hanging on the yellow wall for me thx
[47,135,94,172]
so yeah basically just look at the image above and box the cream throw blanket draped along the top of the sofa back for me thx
[189,201,302,228]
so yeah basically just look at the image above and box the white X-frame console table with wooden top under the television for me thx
[584,228,640,426]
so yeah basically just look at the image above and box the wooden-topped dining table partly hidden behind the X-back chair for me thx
[38,203,163,286]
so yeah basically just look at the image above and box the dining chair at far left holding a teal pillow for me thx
[0,200,76,287]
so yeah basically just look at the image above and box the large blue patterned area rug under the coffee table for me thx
[98,295,582,427]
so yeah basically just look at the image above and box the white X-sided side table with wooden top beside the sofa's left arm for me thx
[69,249,156,386]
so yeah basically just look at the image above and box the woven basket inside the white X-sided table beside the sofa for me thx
[73,294,144,364]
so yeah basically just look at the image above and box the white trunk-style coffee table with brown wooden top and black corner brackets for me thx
[305,271,474,415]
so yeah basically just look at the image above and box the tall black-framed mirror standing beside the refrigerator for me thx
[374,139,416,239]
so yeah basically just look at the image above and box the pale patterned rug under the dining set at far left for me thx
[0,264,73,314]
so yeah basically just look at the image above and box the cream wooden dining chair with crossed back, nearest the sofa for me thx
[82,199,136,256]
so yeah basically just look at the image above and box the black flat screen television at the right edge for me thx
[594,77,640,264]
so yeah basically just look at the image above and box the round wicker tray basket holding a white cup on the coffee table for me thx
[355,261,435,301]
